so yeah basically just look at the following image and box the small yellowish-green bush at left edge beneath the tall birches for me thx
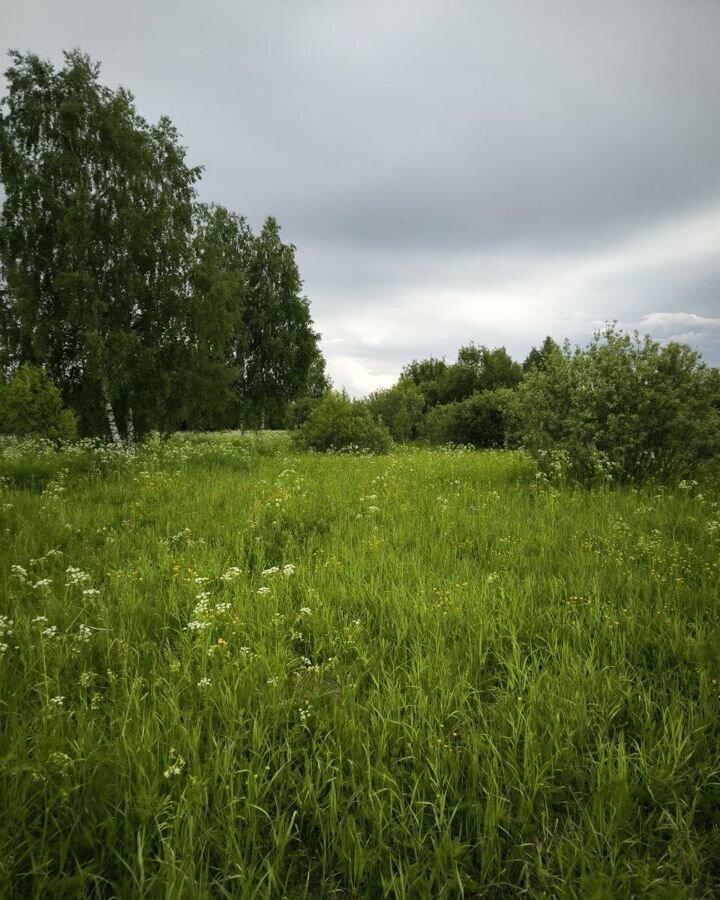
[0,365,77,441]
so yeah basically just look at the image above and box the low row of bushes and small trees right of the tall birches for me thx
[295,325,720,484]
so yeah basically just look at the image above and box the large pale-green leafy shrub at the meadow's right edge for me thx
[514,328,720,483]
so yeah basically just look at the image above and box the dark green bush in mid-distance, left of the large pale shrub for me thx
[423,388,512,448]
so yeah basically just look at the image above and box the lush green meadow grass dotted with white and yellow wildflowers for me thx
[0,435,720,900]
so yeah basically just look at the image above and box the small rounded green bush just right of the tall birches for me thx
[293,392,392,453]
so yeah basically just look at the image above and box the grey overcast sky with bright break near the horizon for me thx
[0,0,720,395]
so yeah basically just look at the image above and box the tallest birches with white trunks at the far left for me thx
[0,51,199,447]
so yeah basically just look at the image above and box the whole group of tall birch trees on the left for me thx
[0,50,328,448]
